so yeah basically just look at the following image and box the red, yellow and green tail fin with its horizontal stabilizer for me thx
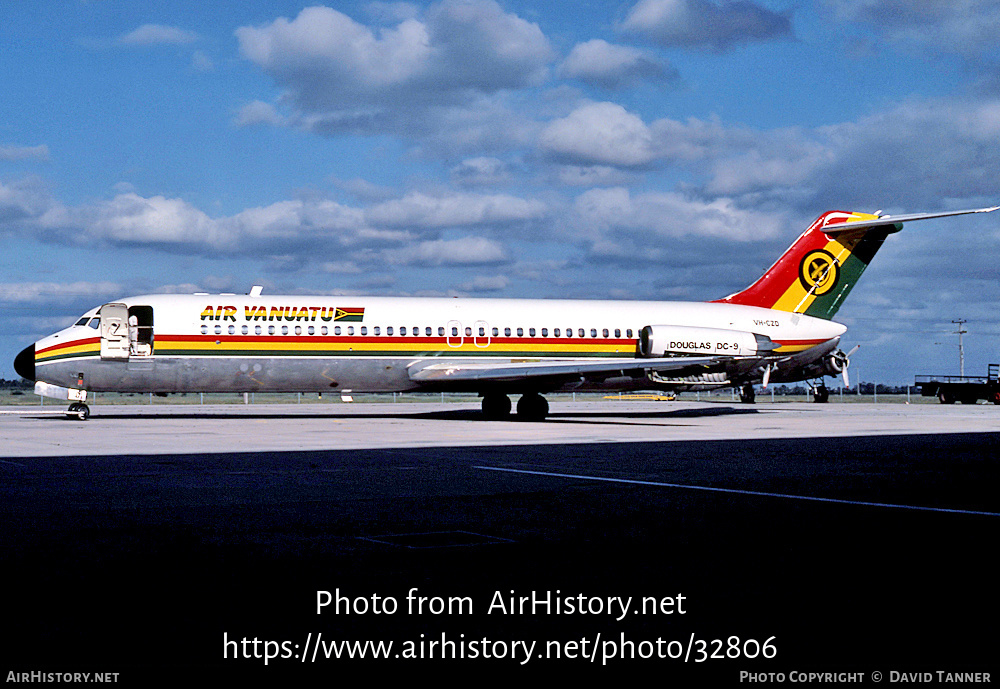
[717,206,1000,319]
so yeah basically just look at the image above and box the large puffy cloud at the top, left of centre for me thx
[236,0,554,132]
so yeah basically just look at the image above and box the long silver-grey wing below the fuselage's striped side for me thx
[408,356,731,386]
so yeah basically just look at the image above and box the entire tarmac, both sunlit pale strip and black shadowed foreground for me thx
[0,401,1000,686]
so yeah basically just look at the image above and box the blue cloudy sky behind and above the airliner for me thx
[0,0,1000,383]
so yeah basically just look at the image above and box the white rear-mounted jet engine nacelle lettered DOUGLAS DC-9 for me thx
[639,325,778,358]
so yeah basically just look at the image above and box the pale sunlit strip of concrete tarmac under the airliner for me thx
[0,400,1000,457]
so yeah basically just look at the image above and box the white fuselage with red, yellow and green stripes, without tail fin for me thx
[29,295,845,392]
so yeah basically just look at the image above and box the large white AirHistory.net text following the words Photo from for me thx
[486,589,687,622]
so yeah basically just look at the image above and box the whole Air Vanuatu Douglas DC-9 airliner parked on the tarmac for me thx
[14,206,1000,420]
